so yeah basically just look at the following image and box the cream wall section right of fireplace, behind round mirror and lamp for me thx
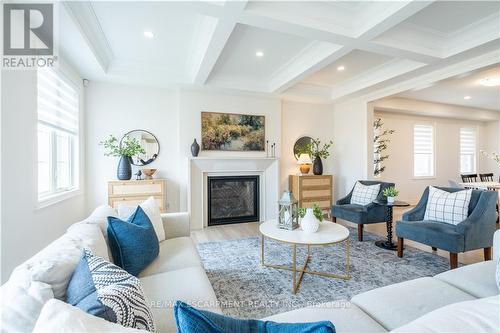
[281,101,337,191]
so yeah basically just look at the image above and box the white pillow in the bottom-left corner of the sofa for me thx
[0,281,54,332]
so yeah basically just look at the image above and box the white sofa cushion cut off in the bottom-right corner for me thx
[392,296,500,333]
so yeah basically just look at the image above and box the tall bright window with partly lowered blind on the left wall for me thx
[37,68,79,202]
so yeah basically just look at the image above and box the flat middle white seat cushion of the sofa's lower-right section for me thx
[351,277,475,330]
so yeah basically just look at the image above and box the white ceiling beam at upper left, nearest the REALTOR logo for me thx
[62,1,114,73]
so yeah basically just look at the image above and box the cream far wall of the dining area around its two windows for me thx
[375,112,488,203]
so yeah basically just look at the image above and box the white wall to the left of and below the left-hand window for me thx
[1,70,85,282]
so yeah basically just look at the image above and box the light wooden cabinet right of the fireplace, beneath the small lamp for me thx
[288,175,333,211]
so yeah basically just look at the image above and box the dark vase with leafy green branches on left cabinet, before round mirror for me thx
[99,135,146,180]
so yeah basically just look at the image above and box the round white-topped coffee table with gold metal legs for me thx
[259,220,351,294]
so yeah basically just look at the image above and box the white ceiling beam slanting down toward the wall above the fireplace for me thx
[191,1,247,85]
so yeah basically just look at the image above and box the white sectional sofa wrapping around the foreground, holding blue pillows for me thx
[0,206,500,333]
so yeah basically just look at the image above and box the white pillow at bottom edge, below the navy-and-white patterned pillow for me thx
[33,299,147,333]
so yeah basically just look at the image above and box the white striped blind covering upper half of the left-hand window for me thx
[38,68,79,134]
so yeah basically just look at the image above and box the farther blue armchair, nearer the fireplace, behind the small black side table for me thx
[332,180,394,242]
